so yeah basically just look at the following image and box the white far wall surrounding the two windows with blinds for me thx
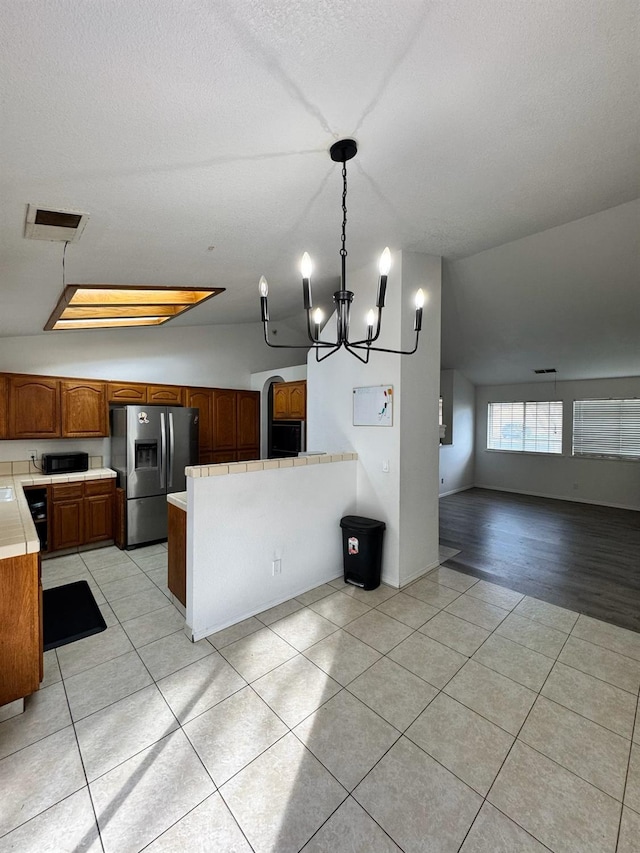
[475,376,640,510]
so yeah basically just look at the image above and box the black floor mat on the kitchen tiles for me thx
[42,581,107,652]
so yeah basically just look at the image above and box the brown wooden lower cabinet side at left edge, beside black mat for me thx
[0,554,43,705]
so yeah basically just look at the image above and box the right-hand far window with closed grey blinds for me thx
[573,400,640,459]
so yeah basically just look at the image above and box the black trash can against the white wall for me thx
[340,515,386,589]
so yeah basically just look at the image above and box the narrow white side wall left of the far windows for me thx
[439,370,475,497]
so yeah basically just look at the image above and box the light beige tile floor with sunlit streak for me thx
[0,545,640,853]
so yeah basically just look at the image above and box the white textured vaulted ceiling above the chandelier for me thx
[0,0,640,381]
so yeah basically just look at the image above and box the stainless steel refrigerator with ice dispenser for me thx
[109,405,199,548]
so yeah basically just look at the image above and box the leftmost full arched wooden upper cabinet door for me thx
[9,376,60,438]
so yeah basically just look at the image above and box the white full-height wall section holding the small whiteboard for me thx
[307,253,441,587]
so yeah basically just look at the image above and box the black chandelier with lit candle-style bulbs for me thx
[258,139,424,364]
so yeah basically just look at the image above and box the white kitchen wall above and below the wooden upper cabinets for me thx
[0,323,301,461]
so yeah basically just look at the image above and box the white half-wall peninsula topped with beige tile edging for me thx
[175,453,358,641]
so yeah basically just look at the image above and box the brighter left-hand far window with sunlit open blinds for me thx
[487,400,562,453]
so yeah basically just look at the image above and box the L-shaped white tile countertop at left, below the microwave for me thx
[0,468,116,560]
